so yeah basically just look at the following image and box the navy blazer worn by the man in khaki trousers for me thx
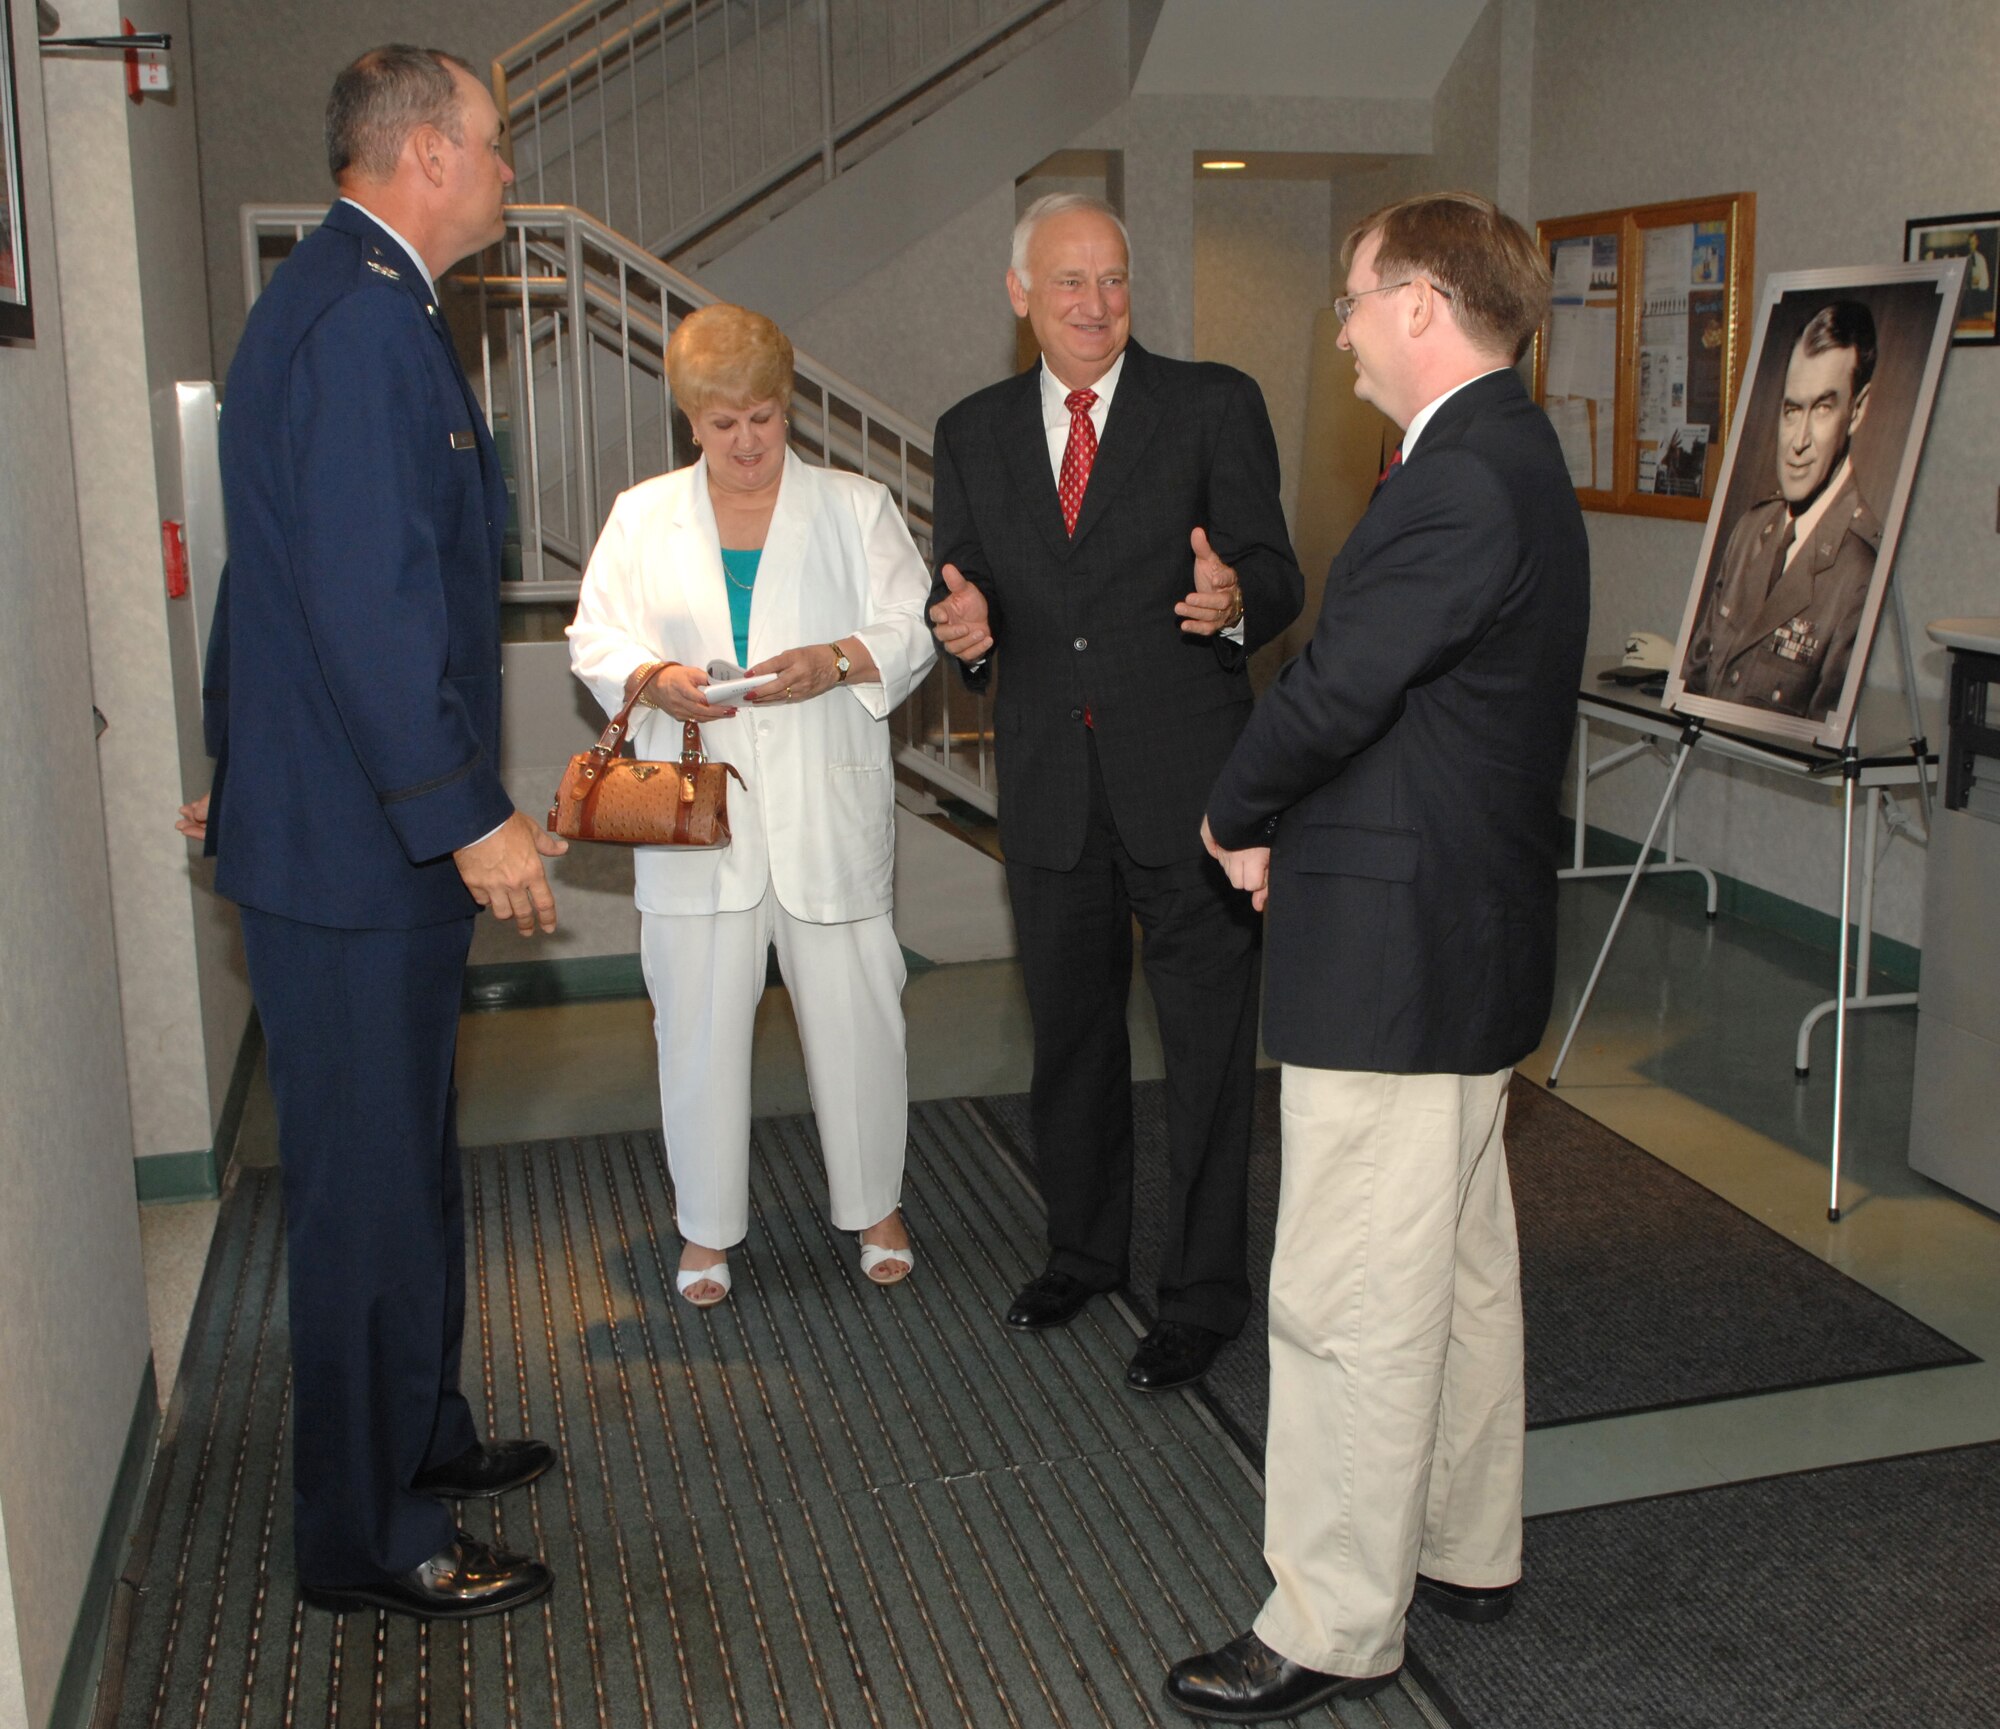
[1208,372,1590,1075]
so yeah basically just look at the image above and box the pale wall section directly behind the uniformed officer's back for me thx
[46,0,250,1157]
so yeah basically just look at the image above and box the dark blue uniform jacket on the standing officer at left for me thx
[202,204,514,929]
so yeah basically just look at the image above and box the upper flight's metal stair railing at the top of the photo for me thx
[492,0,1066,258]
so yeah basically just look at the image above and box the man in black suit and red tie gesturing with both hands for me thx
[932,194,1304,1393]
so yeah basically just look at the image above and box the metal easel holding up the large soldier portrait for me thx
[1548,574,1930,1223]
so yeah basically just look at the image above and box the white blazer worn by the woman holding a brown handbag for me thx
[568,450,936,925]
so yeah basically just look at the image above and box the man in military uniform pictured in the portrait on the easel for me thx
[1682,300,1882,720]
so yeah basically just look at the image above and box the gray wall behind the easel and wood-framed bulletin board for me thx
[1532,0,2000,943]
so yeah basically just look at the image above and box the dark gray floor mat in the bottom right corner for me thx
[1410,1445,2000,1729]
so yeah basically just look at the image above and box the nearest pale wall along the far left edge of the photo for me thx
[0,6,148,1725]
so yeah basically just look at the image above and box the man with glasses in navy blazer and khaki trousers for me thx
[1166,194,1590,1723]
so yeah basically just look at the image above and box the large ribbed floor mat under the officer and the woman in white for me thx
[100,1105,1436,1729]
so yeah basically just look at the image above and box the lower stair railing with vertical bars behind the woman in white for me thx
[242,204,998,814]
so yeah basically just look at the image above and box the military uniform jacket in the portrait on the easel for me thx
[1682,472,1882,720]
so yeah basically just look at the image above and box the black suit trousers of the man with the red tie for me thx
[1008,746,1260,1337]
